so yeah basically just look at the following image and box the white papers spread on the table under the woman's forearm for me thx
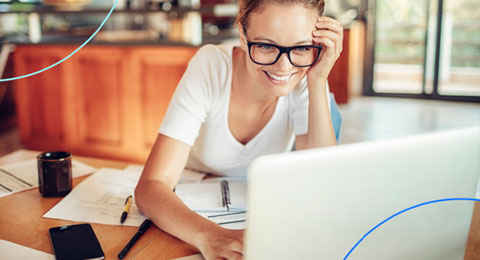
[43,165,246,229]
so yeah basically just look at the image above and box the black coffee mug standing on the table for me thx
[37,151,72,197]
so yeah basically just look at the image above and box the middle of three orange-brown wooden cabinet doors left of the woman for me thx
[70,46,130,159]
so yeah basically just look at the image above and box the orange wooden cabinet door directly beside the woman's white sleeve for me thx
[130,47,197,158]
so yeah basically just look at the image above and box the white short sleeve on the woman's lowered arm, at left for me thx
[159,45,222,146]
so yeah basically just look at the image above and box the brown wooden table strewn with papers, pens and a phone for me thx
[0,150,480,260]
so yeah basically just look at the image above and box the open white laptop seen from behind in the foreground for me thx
[244,128,480,260]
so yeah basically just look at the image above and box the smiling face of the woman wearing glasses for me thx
[239,3,317,97]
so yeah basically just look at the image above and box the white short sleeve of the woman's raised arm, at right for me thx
[290,77,330,136]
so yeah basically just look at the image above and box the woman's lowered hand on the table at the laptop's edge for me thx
[198,226,244,260]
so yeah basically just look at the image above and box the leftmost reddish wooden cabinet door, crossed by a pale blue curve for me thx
[14,46,73,150]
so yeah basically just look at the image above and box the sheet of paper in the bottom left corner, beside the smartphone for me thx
[0,239,55,260]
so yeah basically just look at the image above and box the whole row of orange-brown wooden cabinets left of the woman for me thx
[14,45,197,163]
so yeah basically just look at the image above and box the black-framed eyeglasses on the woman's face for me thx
[245,39,322,67]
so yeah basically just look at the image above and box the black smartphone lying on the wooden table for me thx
[49,224,105,260]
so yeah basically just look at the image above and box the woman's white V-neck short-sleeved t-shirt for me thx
[159,44,329,176]
